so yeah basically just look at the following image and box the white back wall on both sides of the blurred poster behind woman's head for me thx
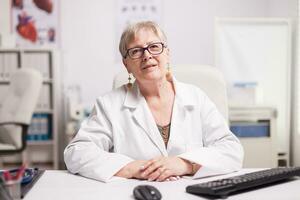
[61,0,297,106]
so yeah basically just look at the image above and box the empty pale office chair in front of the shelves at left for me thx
[0,68,43,155]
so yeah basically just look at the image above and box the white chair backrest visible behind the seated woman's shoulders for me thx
[113,65,228,121]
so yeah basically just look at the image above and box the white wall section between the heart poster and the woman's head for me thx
[61,0,117,108]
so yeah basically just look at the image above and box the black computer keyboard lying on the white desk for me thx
[186,167,300,198]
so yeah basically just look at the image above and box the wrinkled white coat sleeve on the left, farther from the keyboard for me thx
[64,98,132,182]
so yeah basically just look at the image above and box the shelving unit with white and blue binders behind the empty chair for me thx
[0,48,59,169]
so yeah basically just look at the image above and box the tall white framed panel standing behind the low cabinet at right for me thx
[215,17,297,165]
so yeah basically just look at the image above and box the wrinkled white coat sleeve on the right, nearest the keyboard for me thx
[180,92,244,178]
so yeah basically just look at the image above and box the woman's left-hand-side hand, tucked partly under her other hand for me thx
[115,160,148,179]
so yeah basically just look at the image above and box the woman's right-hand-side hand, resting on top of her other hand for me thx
[141,156,193,181]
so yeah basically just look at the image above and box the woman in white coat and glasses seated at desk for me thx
[64,21,243,182]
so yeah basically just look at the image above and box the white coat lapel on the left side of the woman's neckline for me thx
[124,83,167,156]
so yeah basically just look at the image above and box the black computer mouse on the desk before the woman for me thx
[133,185,161,200]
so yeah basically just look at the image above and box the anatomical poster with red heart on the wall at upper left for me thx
[12,0,58,47]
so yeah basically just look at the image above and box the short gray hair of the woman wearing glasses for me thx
[119,21,167,58]
